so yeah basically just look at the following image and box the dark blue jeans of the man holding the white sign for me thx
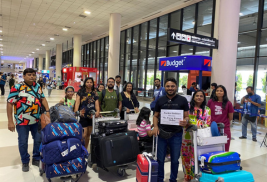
[157,132,183,182]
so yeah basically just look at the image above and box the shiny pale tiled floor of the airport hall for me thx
[0,90,267,182]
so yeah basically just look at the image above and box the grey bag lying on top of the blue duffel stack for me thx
[49,104,77,123]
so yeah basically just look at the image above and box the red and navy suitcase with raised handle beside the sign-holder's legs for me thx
[136,136,158,182]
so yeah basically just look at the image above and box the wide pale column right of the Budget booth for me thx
[211,0,241,103]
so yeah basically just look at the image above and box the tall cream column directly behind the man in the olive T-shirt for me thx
[108,13,121,77]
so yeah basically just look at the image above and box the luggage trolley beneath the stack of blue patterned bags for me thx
[39,112,84,182]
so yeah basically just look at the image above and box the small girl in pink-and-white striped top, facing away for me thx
[136,107,153,142]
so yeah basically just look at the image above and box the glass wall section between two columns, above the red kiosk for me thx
[81,37,109,83]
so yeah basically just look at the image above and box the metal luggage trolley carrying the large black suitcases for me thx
[87,108,134,176]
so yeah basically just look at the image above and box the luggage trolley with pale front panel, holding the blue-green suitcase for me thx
[187,123,227,182]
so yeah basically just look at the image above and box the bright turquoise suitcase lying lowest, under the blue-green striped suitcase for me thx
[200,170,255,182]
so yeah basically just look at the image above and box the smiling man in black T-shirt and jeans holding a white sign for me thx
[153,78,189,182]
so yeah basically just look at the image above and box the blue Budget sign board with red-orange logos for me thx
[159,55,212,71]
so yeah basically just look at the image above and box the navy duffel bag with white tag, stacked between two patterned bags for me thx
[41,138,87,164]
